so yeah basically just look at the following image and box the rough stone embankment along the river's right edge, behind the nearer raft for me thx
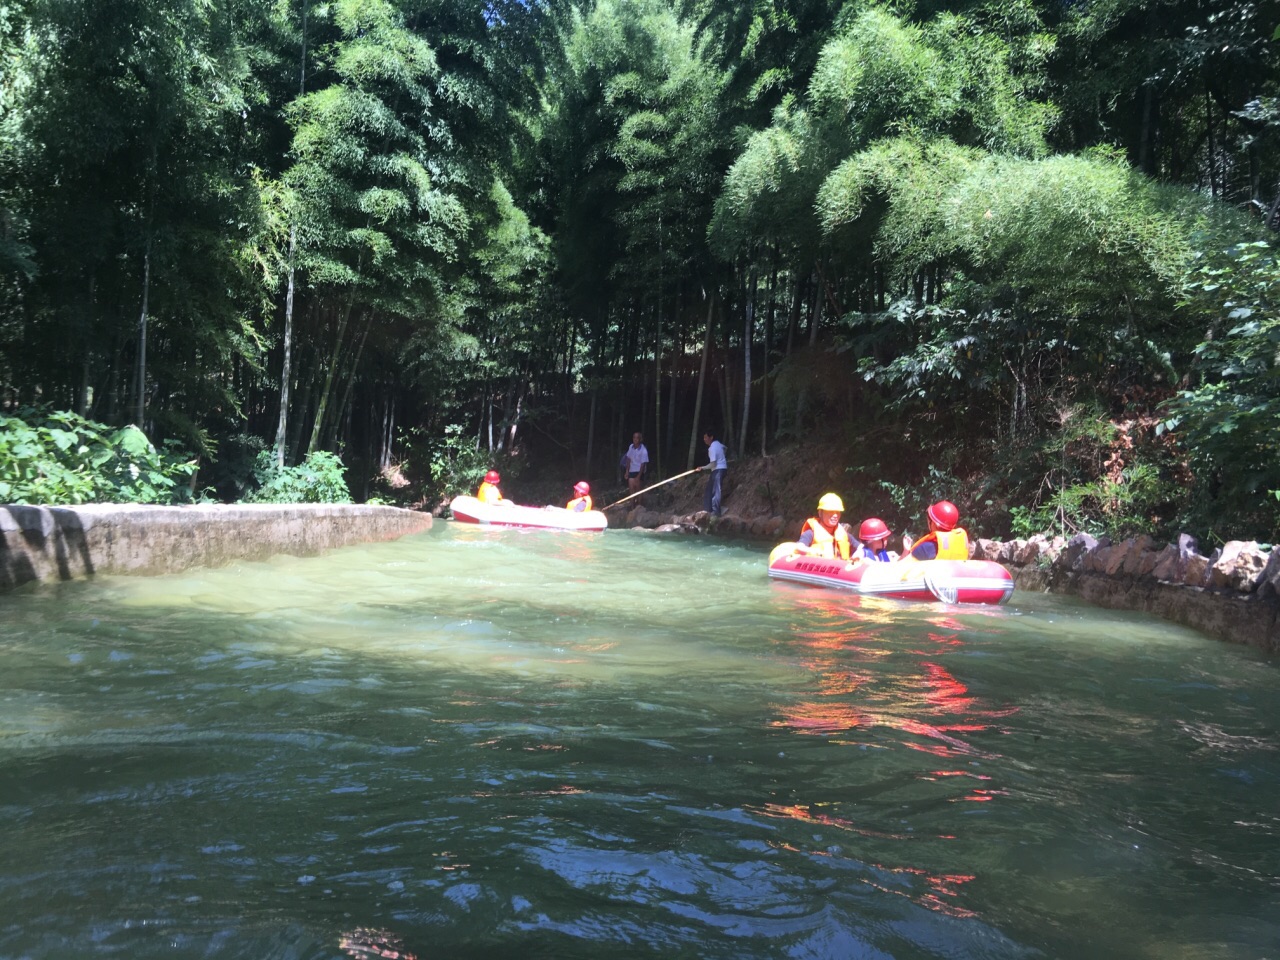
[609,508,1280,653]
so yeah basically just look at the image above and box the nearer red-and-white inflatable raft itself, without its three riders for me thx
[769,543,1014,603]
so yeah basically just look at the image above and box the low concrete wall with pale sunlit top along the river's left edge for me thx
[0,503,431,590]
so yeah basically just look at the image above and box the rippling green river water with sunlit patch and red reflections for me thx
[0,524,1280,960]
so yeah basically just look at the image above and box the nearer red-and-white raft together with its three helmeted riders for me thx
[769,493,1014,604]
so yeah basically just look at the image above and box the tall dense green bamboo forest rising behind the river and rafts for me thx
[0,0,1280,539]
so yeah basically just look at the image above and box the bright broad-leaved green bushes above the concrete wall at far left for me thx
[0,408,196,504]
